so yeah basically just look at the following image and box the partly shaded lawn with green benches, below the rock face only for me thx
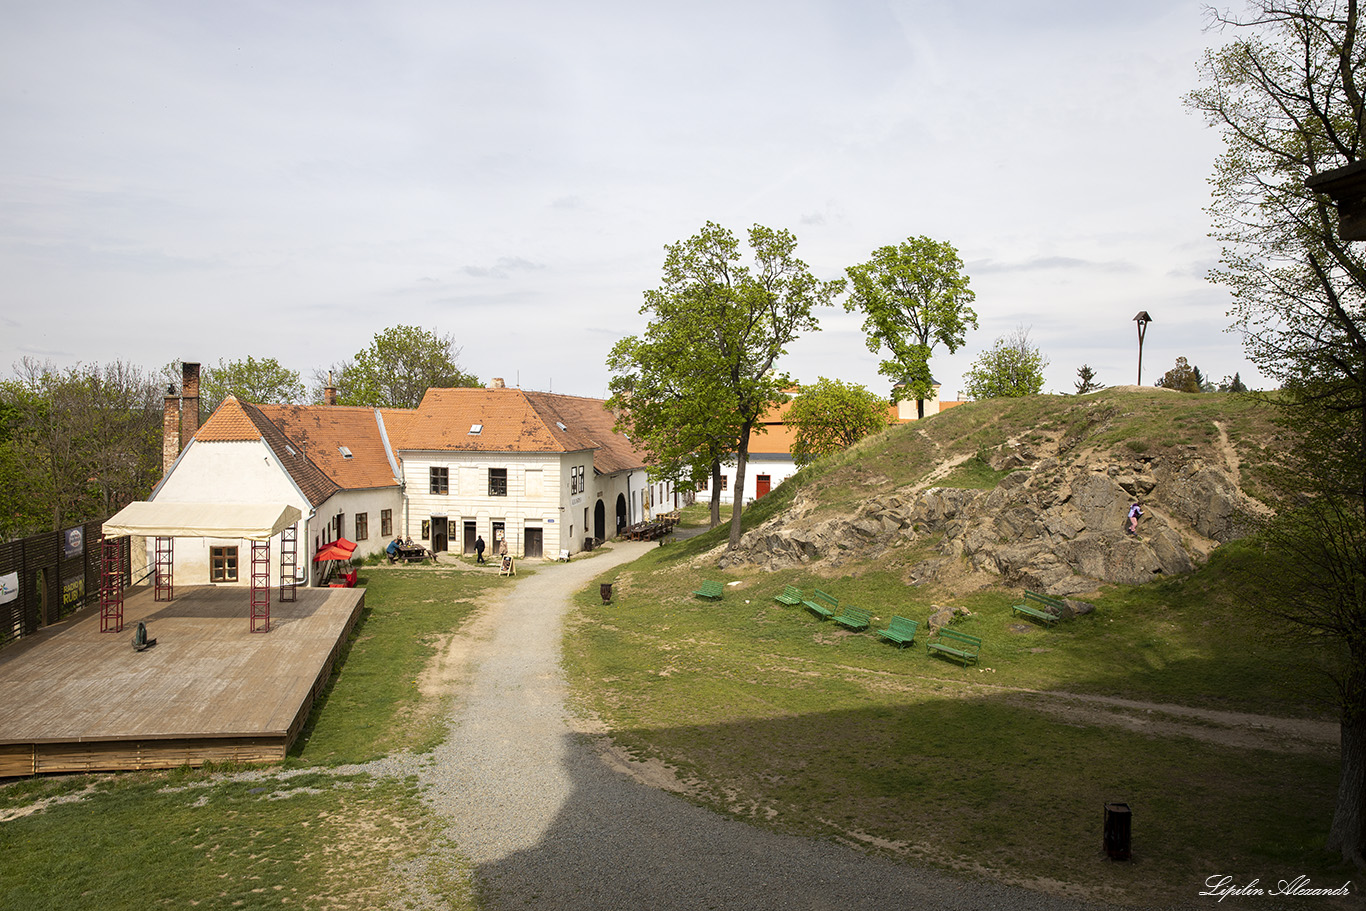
[566,533,1354,907]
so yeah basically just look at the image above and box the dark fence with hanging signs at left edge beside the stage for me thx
[0,520,133,645]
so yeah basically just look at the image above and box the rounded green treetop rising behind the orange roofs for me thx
[336,326,479,408]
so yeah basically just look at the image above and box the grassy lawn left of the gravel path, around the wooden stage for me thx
[0,567,505,911]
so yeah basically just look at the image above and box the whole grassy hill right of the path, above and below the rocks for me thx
[566,389,1350,907]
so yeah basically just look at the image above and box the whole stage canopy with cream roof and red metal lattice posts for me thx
[100,501,303,632]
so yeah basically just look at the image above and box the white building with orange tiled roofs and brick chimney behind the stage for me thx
[150,365,675,586]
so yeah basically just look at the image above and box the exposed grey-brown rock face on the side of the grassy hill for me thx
[721,445,1262,595]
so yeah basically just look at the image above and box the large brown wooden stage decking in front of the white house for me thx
[0,586,365,777]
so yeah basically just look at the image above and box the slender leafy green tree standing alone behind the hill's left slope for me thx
[844,236,977,418]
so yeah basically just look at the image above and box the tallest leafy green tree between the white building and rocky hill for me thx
[608,221,843,549]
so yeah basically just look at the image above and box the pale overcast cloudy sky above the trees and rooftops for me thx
[0,0,1255,397]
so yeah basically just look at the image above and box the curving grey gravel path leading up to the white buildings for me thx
[407,544,1109,911]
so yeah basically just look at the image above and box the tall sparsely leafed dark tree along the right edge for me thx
[1188,0,1366,866]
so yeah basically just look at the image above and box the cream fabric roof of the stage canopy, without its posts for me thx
[104,501,303,541]
